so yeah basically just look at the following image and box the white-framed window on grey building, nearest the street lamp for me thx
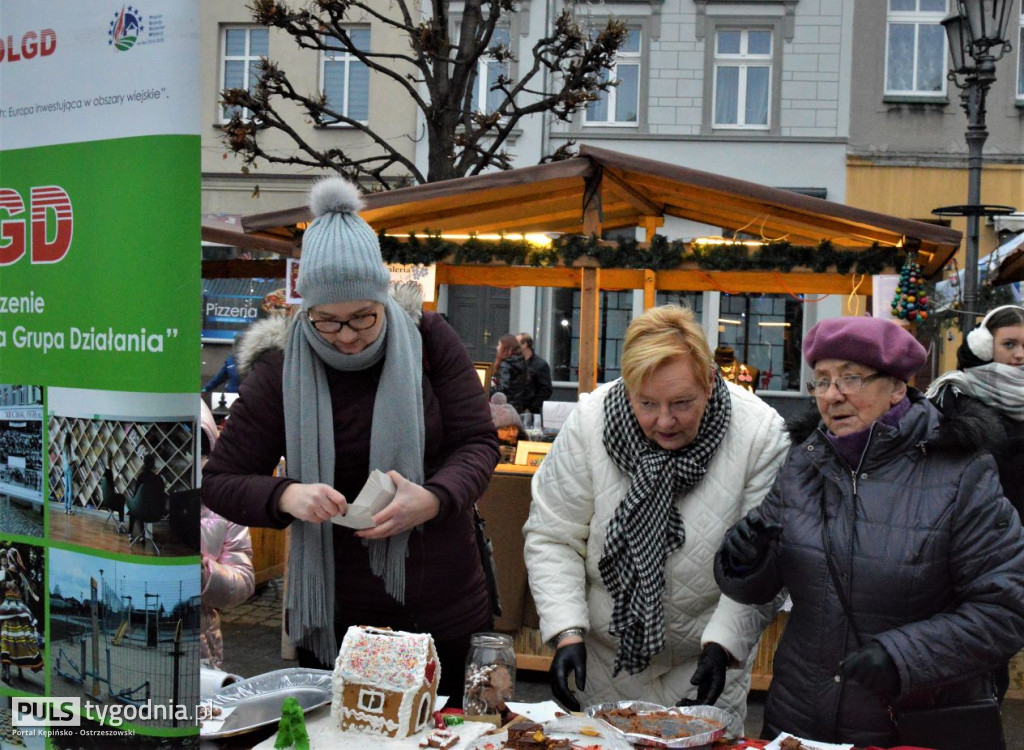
[886,0,946,96]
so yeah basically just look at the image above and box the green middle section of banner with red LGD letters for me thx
[0,135,201,392]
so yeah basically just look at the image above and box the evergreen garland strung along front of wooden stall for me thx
[379,233,906,276]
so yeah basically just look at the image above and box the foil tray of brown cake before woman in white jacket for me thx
[584,701,735,750]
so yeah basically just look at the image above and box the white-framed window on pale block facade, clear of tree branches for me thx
[713,27,773,130]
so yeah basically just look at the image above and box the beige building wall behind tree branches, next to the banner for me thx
[200,0,416,214]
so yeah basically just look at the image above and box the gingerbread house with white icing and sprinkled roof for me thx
[331,625,441,739]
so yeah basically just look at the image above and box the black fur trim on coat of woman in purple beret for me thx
[785,387,1006,454]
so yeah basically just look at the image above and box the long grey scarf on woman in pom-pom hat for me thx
[283,297,424,664]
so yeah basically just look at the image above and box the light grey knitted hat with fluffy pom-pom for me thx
[296,177,391,310]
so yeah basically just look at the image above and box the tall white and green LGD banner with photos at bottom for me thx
[0,0,201,750]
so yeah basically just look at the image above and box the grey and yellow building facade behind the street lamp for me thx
[846,0,1024,371]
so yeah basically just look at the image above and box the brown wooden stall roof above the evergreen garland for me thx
[204,145,961,276]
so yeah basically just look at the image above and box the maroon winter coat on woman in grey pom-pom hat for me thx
[203,313,499,639]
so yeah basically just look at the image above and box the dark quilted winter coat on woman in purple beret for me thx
[715,389,1024,747]
